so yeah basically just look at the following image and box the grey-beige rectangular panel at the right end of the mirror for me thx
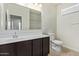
[30,10,41,29]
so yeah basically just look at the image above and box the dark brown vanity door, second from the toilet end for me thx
[33,38,42,56]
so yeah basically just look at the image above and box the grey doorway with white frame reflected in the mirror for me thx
[7,15,22,30]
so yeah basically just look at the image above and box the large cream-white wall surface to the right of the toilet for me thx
[57,3,79,52]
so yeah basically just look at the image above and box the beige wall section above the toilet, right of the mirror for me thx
[42,3,57,33]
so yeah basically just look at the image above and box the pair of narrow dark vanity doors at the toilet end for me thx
[33,37,50,56]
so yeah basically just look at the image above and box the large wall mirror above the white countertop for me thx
[0,3,41,30]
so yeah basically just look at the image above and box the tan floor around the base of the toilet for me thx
[49,47,79,56]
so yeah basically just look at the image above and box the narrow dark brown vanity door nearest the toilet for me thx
[42,37,49,56]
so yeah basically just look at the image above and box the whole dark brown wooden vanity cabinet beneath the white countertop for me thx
[0,36,49,56]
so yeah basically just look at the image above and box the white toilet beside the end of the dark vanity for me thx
[48,33,63,52]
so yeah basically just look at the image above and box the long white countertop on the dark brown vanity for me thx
[0,34,49,45]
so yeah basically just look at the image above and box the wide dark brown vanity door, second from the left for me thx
[16,41,32,56]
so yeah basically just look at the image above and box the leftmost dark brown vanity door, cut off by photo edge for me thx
[0,44,16,56]
